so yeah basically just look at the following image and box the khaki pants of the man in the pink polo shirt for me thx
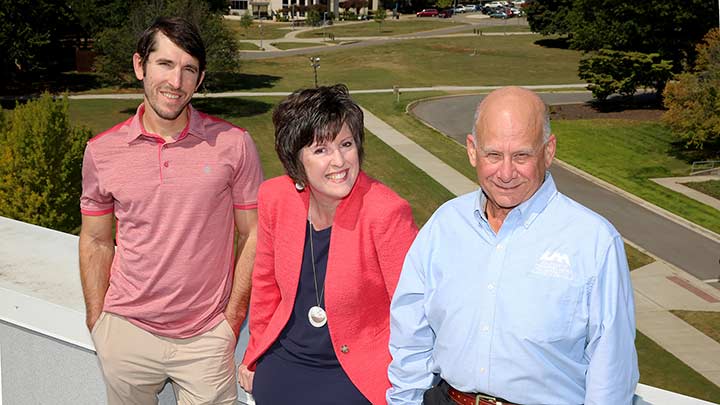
[92,312,237,405]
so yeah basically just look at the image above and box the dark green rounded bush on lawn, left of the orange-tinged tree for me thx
[578,49,672,101]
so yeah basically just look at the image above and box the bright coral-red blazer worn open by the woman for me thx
[243,172,417,404]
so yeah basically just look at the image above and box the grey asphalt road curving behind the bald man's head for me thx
[413,92,720,287]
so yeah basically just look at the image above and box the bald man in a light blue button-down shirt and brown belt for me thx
[387,87,639,405]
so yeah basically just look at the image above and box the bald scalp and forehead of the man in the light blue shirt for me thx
[472,86,551,143]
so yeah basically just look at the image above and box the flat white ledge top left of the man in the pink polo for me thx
[0,217,95,351]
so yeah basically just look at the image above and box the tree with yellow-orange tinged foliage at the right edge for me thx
[663,28,720,158]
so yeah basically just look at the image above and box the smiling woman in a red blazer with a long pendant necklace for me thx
[239,85,417,405]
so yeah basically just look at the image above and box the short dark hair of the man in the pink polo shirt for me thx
[135,17,206,72]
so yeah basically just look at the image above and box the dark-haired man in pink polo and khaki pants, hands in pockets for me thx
[80,18,262,405]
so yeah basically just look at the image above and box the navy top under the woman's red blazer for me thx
[252,221,370,405]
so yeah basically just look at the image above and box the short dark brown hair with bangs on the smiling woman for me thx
[273,84,365,184]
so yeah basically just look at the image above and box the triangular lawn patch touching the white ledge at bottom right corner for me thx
[635,332,720,403]
